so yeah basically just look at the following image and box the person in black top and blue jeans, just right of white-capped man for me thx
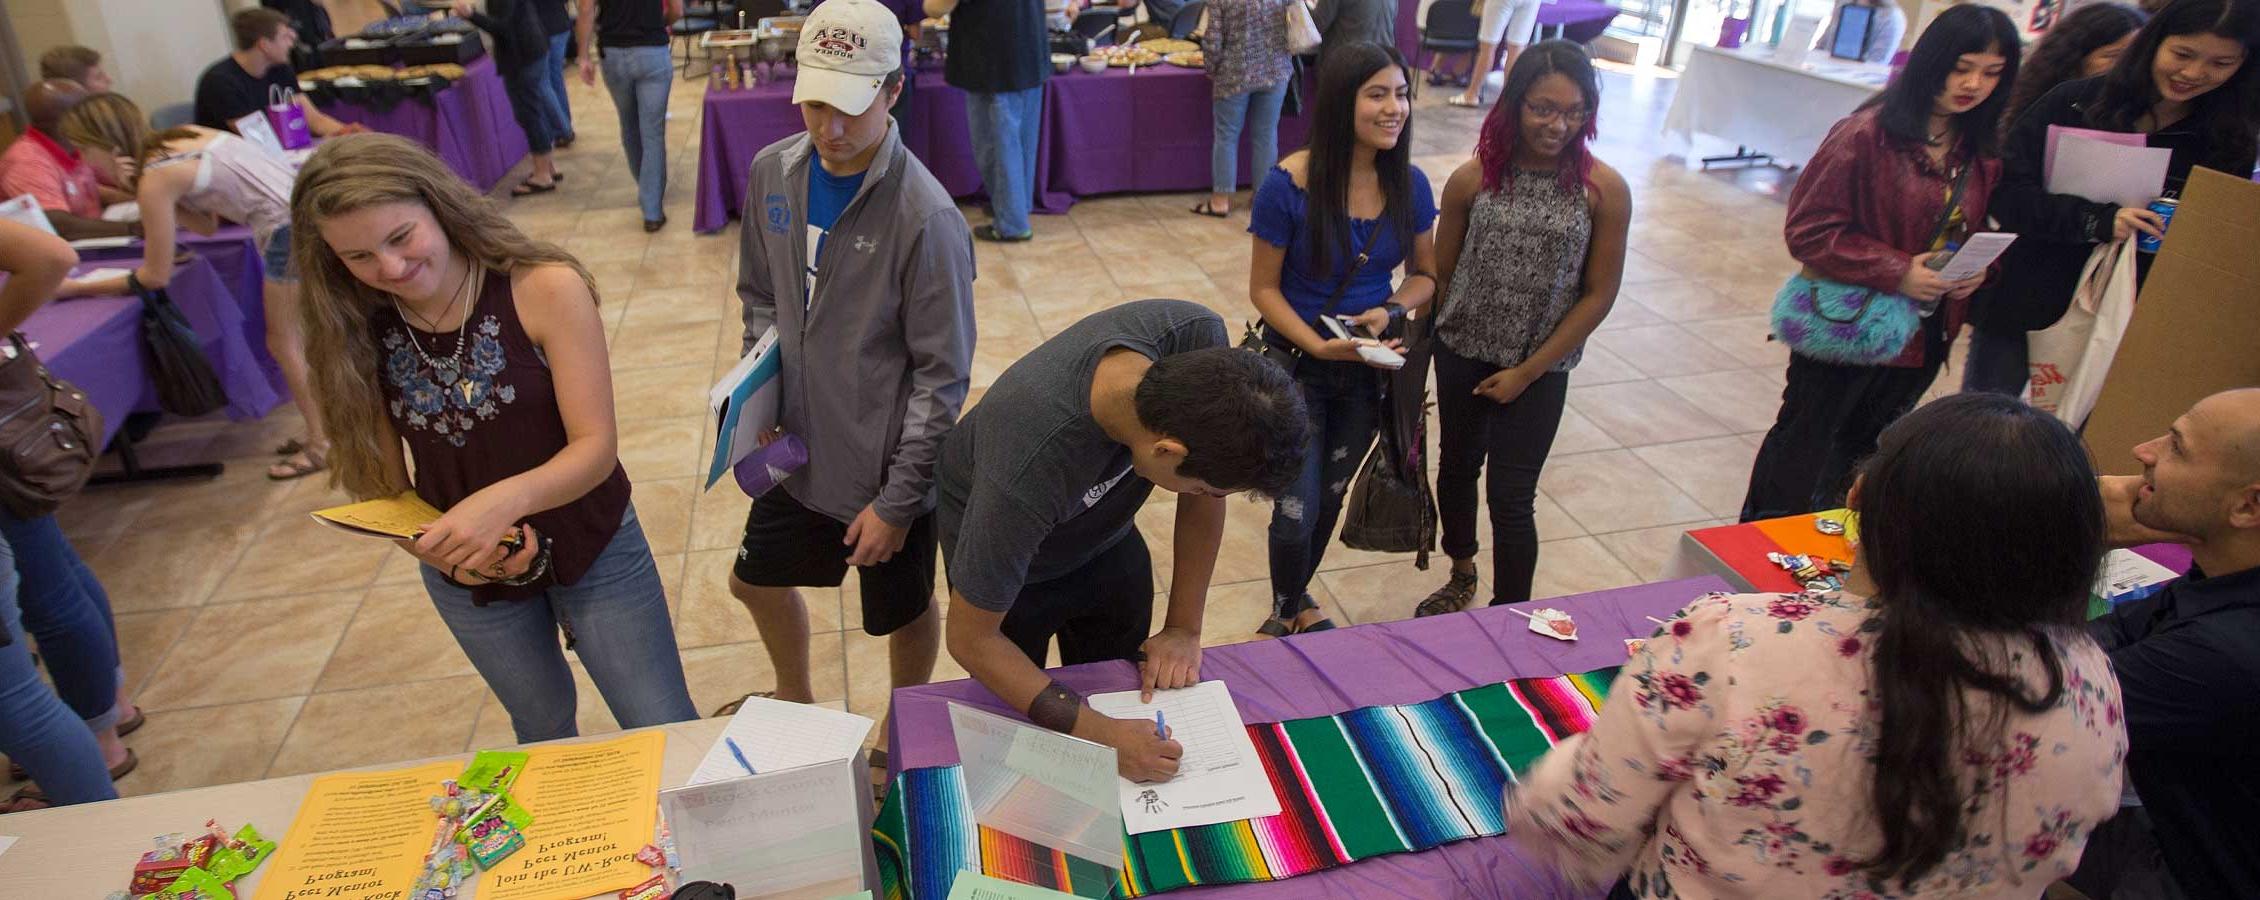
[924,0,1051,242]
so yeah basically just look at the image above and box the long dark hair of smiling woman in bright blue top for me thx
[1304,41,1413,278]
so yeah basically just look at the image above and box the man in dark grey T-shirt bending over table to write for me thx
[936,301,1311,780]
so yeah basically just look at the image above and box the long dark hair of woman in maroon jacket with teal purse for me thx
[1874,2,2023,156]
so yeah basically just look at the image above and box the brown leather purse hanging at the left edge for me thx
[0,332,102,518]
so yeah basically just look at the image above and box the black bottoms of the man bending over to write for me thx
[999,529,1153,669]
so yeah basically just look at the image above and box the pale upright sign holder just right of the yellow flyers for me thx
[660,758,877,900]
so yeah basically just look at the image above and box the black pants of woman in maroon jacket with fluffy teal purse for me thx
[1742,350,1946,522]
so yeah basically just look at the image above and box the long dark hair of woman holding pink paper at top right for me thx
[2088,0,2260,161]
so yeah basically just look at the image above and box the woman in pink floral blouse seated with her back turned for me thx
[1507,393,2127,900]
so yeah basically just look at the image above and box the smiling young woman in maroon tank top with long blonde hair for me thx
[292,136,696,742]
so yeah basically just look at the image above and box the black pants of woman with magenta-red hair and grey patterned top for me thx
[1435,341,1568,606]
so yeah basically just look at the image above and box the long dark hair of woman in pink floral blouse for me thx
[1853,393,2104,889]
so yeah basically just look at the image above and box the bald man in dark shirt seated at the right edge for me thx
[2079,389,2260,900]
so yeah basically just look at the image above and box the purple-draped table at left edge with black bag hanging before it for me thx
[23,260,283,443]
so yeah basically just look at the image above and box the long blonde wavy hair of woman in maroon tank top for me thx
[289,133,597,500]
